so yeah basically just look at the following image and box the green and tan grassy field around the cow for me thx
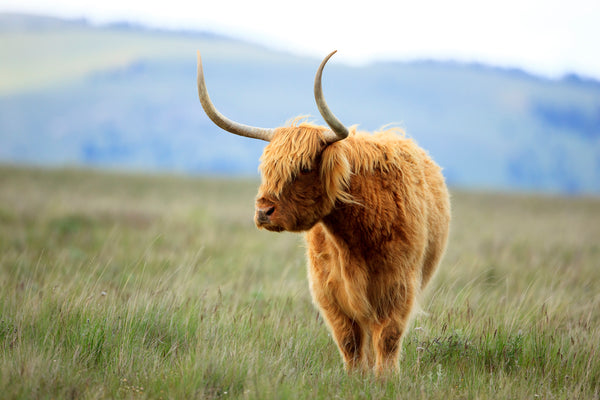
[0,167,600,399]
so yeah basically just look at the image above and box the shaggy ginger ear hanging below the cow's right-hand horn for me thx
[320,140,354,205]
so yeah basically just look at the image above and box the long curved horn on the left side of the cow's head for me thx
[198,52,275,142]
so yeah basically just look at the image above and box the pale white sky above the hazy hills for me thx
[0,0,600,79]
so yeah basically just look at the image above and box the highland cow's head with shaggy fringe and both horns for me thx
[198,51,350,232]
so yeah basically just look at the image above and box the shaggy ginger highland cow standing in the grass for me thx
[198,52,450,374]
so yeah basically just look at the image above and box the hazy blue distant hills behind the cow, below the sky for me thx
[0,14,600,194]
